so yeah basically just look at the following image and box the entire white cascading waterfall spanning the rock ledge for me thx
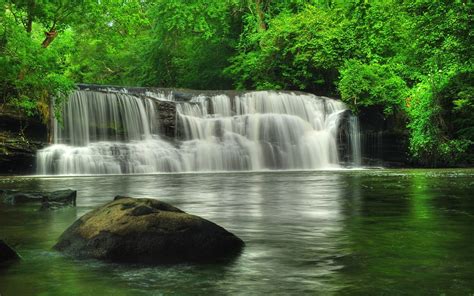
[37,91,360,174]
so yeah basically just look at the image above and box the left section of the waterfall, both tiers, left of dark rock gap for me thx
[37,91,182,174]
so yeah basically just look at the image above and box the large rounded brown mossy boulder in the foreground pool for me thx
[54,197,244,263]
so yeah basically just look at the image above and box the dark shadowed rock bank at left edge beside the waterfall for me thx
[0,106,47,175]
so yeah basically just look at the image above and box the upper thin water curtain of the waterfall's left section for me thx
[55,90,157,146]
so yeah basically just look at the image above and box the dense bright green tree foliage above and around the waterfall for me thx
[0,0,474,165]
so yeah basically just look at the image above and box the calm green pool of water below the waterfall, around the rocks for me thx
[0,170,474,295]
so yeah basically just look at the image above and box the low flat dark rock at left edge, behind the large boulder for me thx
[0,189,77,210]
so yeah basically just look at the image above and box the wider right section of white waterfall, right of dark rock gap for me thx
[178,92,346,171]
